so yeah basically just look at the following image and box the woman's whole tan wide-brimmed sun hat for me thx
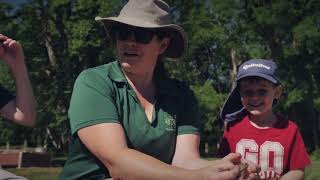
[95,0,187,58]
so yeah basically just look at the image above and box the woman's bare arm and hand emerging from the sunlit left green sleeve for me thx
[78,123,239,180]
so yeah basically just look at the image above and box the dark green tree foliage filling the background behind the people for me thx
[0,0,320,155]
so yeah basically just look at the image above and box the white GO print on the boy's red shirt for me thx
[236,139,284,174]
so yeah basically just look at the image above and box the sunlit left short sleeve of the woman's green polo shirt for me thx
[68,69,119,134]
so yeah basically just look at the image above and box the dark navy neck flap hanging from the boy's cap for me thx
[220,86,248,122]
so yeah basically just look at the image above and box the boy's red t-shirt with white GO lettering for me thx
[219,116,310,179]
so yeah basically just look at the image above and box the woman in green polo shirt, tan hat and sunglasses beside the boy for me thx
[60,0,258,180]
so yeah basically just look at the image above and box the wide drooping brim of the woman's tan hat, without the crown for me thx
[95,17,188,58]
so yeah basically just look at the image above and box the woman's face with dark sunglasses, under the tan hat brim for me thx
[114,26,169,74]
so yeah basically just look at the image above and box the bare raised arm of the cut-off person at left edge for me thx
[0,34,36,126]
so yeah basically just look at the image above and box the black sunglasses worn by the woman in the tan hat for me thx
[110,24,165,44]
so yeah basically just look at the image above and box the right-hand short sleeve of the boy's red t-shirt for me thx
[289,129,310,170]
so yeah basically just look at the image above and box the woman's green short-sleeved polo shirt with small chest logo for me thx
[60,61,200,180]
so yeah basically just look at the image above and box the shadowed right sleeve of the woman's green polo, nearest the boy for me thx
[178,86,201,135]
